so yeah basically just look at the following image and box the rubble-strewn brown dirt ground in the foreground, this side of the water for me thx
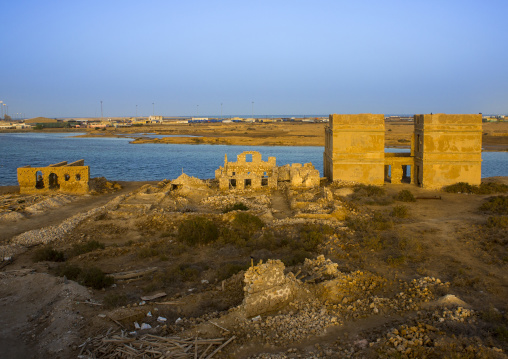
[0,177,508,358]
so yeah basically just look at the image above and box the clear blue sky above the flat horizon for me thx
[0,0,508,117]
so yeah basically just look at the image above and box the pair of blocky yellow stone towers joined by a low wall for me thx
[323,114,482,189]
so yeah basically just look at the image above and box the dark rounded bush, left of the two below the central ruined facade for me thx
[177,216,219,246]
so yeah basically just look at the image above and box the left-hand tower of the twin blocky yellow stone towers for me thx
[323,113,385,185]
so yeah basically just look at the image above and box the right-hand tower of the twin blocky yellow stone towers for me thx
[412,113,482,189]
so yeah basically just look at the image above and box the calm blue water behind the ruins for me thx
[0,133,508,186]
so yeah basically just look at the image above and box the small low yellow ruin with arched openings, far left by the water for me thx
[18,160,90,194]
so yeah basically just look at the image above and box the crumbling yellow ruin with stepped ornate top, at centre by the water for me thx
[215,151,320,190]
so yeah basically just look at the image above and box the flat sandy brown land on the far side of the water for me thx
[29,121,508,151]
